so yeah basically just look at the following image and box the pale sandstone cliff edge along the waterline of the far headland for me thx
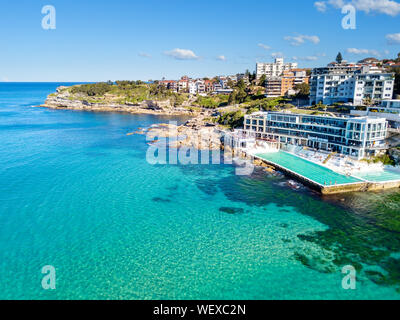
[39,87,198,116]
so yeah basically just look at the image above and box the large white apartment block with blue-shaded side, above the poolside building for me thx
[310,65,394,105]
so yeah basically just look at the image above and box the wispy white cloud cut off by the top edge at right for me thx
[314,0,400,17]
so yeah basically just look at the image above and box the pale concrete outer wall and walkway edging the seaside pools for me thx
[250,151,400,195]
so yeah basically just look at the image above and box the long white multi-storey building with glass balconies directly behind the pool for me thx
[244,112,388,159]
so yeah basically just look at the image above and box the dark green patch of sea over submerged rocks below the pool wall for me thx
[183,162,400,293]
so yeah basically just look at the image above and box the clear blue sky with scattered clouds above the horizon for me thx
[0,0,400,81]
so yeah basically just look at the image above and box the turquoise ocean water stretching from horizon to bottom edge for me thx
[0,83,400,299]
